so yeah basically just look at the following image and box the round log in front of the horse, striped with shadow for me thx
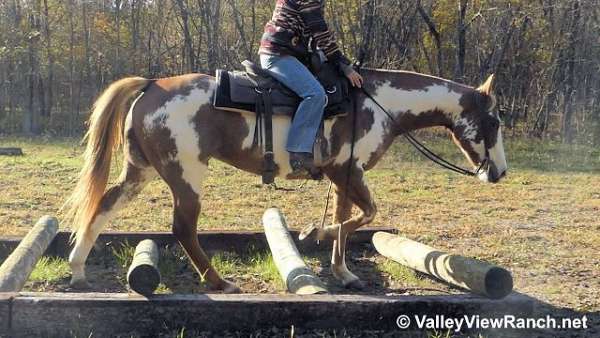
[373,232,513,299]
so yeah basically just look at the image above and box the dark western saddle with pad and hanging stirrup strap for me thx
[213,58,352,184]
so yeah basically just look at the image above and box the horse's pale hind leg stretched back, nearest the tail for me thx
[69,163,156,288]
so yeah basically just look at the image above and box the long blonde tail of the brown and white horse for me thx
[63,77,152,240]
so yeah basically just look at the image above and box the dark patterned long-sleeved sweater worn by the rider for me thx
[258,0,350,64]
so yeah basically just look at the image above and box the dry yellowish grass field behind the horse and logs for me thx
[0,138,600,311]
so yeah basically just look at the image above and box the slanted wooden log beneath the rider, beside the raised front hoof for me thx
[263,208,327,295]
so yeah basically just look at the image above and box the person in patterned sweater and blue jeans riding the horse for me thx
[259,0,363,176]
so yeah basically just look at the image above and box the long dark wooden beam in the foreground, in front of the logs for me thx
[0,292,535,338]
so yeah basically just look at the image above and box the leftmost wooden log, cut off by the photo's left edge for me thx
[0,216,58,292]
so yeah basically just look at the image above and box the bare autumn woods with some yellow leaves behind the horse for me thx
[0,0,600,145]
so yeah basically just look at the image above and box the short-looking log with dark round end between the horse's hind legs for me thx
[127,239,160,296]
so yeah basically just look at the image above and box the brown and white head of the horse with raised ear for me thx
[452,75,508,183]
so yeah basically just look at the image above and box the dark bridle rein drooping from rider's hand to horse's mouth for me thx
[355,87,490,176]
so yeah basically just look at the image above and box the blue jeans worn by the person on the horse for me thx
[260,54,327,154]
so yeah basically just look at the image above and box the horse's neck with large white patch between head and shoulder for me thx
[364,70,468,133]
